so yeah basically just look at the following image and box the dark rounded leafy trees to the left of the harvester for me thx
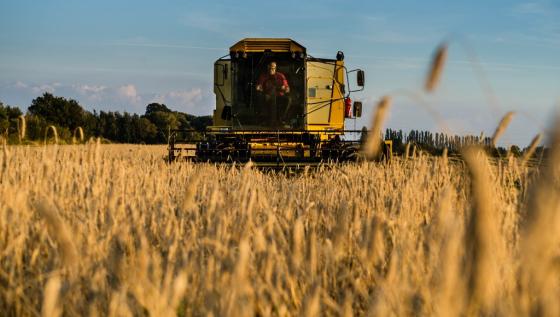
[0,93,212,144]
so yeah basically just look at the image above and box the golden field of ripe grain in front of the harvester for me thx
[0,139,560,316]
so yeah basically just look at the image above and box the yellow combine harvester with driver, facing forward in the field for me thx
[169,38,391,167]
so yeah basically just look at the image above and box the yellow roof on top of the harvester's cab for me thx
[229,38,305,54]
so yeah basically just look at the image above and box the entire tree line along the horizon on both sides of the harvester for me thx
[0,93,545,156]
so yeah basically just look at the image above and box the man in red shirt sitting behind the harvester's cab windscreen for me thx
[256,62,290,126]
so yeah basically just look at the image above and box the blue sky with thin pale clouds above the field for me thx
[0,0,560,146]
